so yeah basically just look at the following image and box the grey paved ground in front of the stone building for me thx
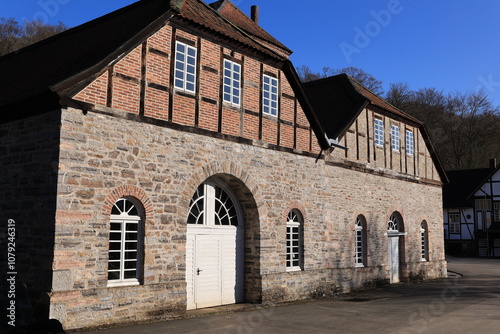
[75,257,500,334]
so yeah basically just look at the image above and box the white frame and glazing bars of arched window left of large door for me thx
[107,198,143,287]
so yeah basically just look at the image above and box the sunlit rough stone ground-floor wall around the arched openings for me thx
[51,109,445,329]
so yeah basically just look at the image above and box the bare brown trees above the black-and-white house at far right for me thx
[386,83,500,170]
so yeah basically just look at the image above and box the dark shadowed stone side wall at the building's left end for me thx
[0,111,61,318]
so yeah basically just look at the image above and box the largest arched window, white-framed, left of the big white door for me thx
[108,198,143,286]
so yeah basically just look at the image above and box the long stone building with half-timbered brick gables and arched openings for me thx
[0,0,446,328]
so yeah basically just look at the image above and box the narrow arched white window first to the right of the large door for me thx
[286,210,303,271]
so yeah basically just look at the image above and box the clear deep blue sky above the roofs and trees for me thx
[0,0,500,105]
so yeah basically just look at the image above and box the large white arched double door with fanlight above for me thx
[186,178,245,309]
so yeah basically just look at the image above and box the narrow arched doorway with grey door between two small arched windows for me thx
[387,212,406,283]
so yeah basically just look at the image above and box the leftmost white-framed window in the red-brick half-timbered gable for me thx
[174,41,197,93]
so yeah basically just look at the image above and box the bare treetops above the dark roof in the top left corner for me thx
[0,18,66,56]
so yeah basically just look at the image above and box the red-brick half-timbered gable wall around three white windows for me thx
[74,25,320,154]
